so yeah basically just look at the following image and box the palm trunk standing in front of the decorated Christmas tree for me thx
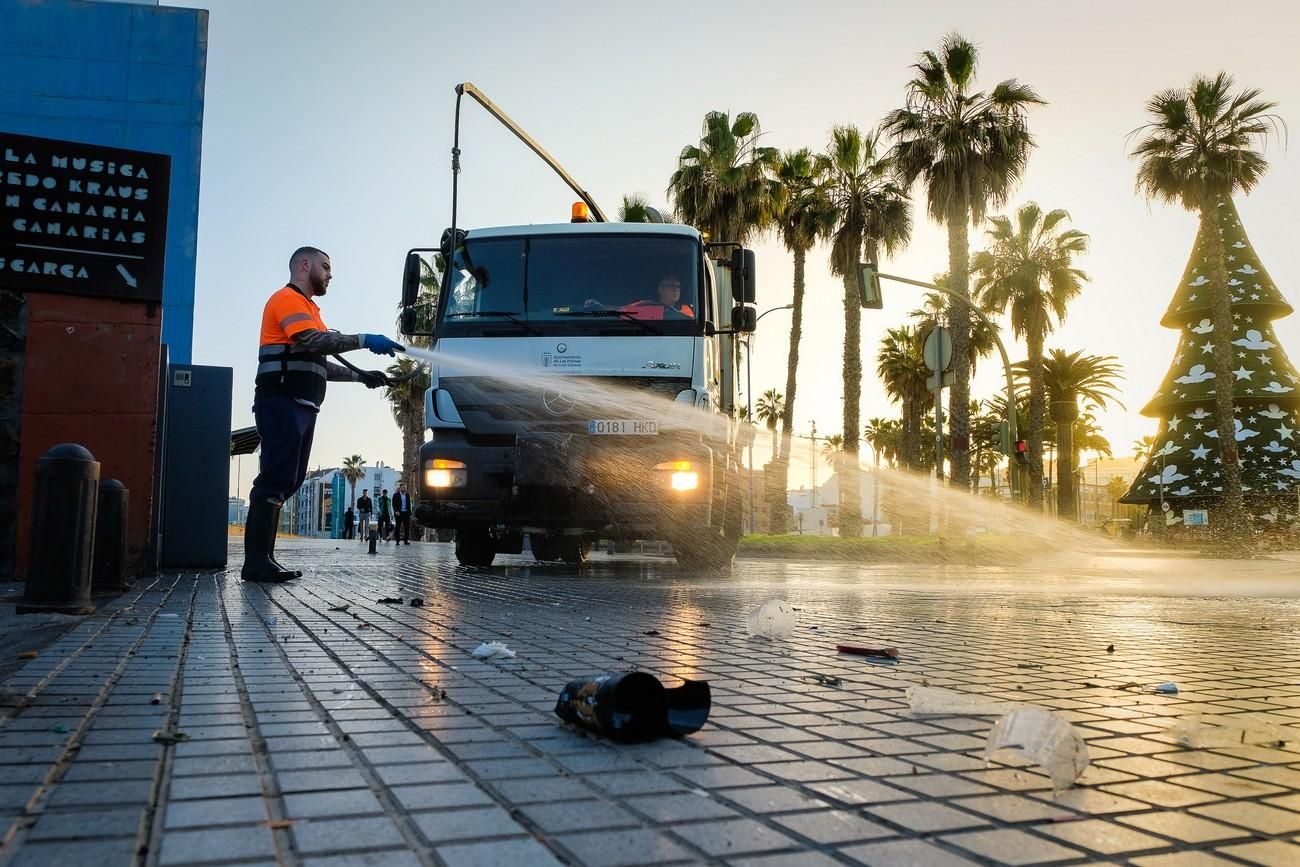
[1201,206,1248,541]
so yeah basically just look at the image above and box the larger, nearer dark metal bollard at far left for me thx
[16,443,99,614]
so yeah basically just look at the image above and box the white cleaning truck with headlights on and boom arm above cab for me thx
[402,84,755,569]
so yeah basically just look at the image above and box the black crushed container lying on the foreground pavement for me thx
[555,671,711,741]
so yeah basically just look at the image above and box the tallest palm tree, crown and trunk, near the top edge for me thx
[885,32,1044,487]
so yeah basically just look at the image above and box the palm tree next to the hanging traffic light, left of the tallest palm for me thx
[818,125,911,536]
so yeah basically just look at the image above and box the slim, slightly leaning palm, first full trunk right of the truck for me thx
[770,148,835,533]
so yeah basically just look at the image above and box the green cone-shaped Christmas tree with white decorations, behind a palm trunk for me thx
[1121,198,1300,523]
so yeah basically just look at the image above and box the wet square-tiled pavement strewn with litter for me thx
[0,542,1300,867]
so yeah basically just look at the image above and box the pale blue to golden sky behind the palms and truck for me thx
[185,0,1300,495]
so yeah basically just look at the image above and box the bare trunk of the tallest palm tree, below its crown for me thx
[935,198,971,489]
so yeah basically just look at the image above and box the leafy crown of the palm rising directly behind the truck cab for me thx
[668,112,781,243]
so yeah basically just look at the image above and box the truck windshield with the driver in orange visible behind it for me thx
[439,234,702,334]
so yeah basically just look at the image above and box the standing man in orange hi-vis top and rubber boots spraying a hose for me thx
[241,247,403,581]
